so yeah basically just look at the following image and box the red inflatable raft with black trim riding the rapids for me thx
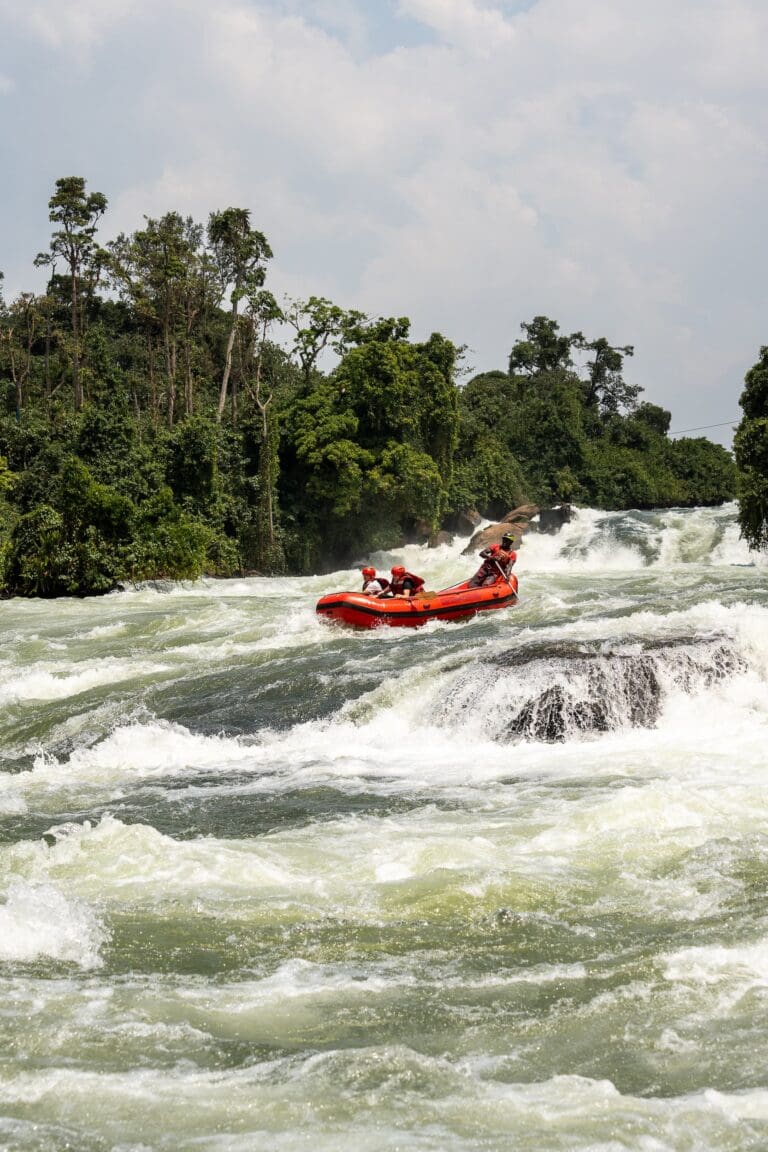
[317,575,517,628]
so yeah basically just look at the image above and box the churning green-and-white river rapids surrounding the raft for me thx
[0,507,768,1152]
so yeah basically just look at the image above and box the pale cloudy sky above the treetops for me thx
[0,0,768,444]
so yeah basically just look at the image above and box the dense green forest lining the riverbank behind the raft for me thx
[0,176,736,596]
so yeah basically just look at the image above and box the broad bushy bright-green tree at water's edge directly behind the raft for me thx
[283,320,458,563]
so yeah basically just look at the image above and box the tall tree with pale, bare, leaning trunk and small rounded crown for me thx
[208,207,272,423]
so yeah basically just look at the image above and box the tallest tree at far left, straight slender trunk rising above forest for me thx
[35,176,107,411]
